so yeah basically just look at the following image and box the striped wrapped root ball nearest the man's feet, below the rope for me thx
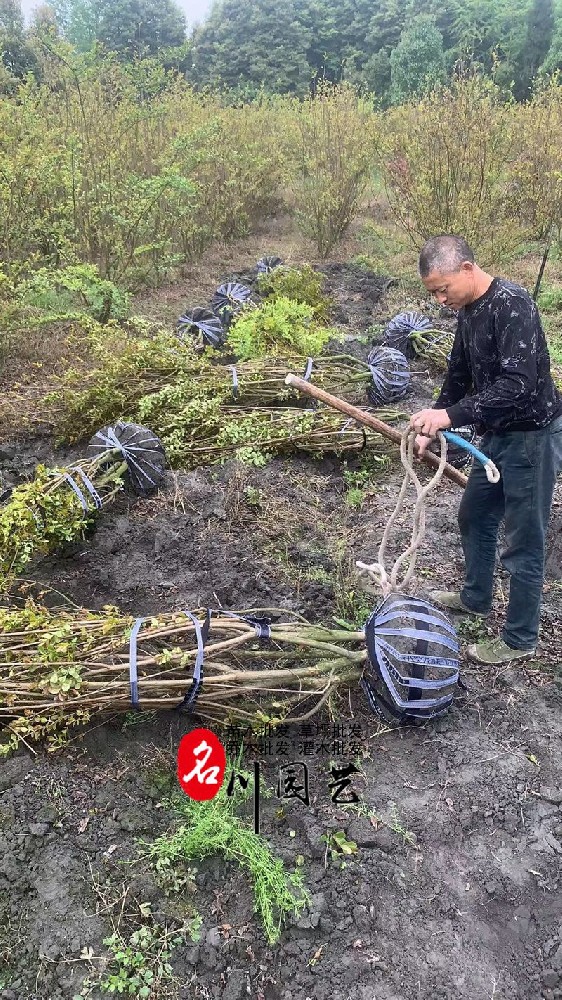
[361,594,459,725]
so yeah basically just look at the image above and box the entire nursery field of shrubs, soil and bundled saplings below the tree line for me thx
[0,65,562,1000]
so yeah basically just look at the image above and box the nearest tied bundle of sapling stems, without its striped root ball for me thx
[0,602,367,752]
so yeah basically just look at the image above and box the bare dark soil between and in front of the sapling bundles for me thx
[0,220,562,1000]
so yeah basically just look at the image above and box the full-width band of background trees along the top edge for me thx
[0,0,562,106]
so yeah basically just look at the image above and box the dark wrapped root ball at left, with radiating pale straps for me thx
[88,420,166,497]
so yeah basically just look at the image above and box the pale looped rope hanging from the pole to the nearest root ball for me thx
[355,427,447,598]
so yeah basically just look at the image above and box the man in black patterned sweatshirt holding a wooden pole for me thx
[410,236,562,665]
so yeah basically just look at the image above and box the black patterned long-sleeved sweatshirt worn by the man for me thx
[434,278,562,434]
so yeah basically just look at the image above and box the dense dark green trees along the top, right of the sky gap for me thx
[191,0,562,105]
